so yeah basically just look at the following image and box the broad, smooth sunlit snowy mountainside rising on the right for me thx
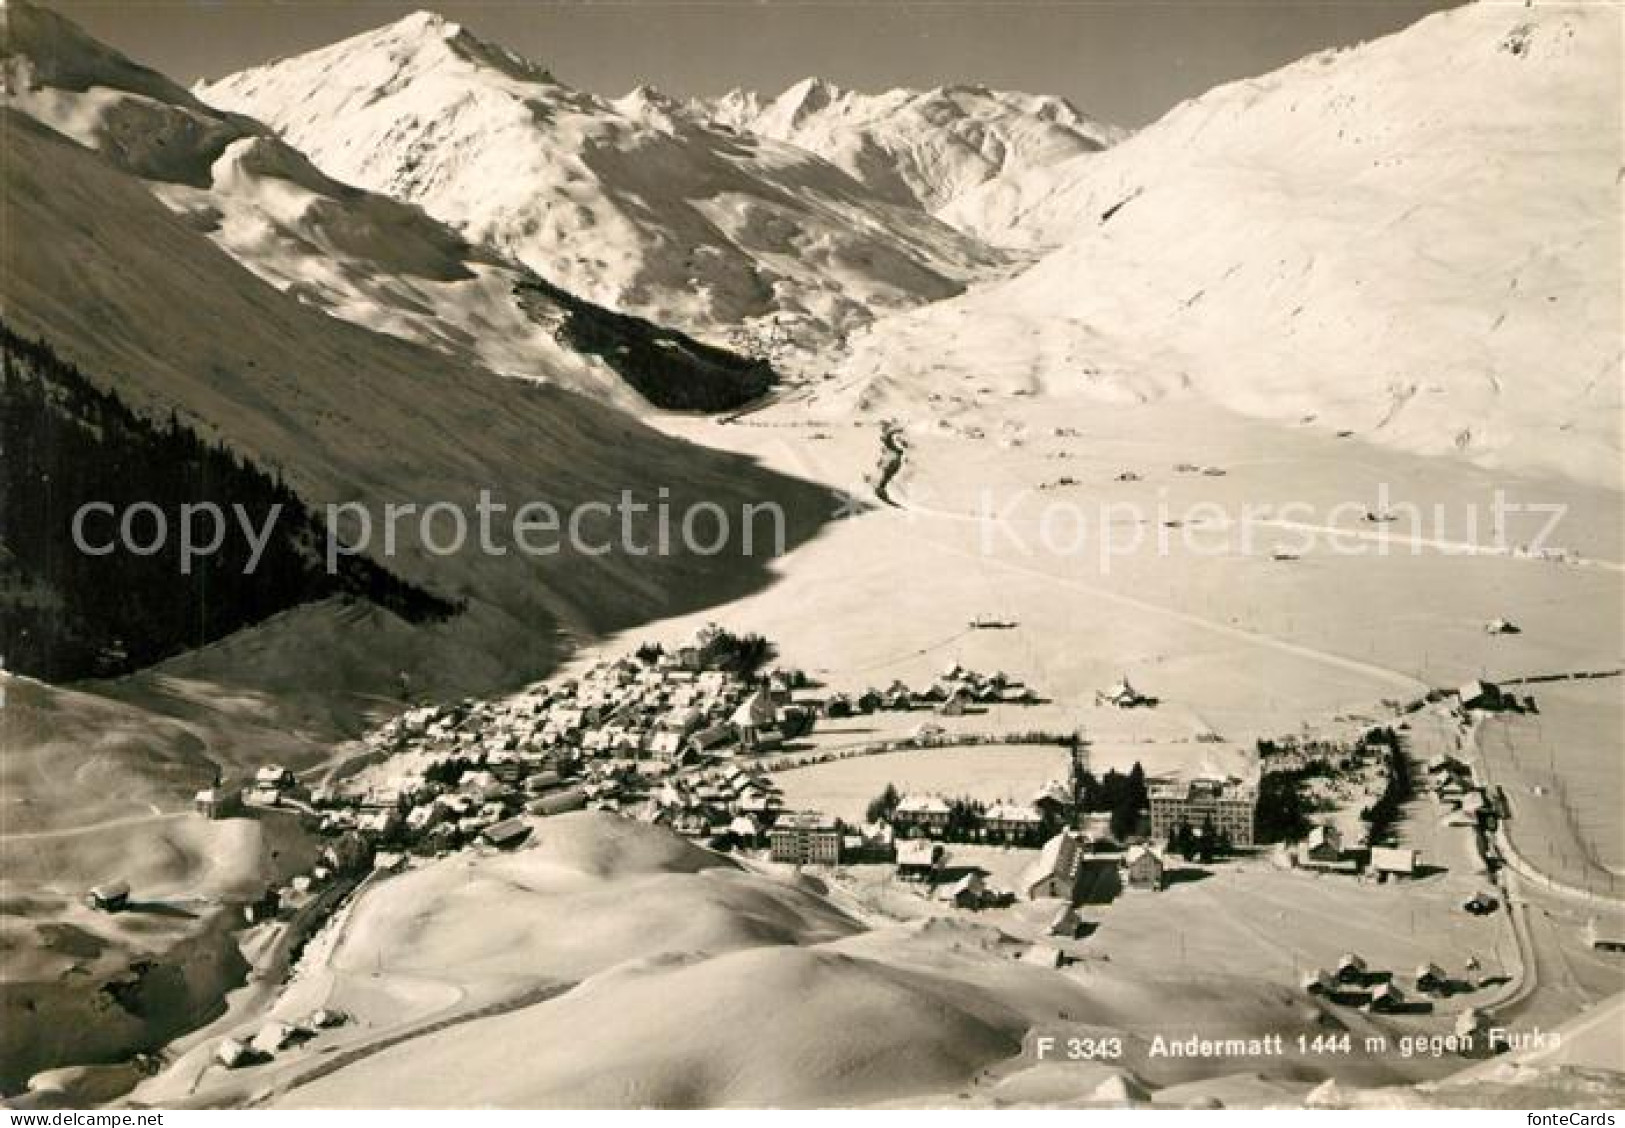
[847,3,1625,489]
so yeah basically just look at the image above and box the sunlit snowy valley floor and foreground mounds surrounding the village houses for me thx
[28,393,1625,1105]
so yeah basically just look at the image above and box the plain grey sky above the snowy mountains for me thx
[47,0,1454,125]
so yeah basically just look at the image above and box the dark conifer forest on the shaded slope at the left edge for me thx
[0,323,457,681]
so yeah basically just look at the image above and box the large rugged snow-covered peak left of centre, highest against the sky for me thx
[200,16,999,344]
